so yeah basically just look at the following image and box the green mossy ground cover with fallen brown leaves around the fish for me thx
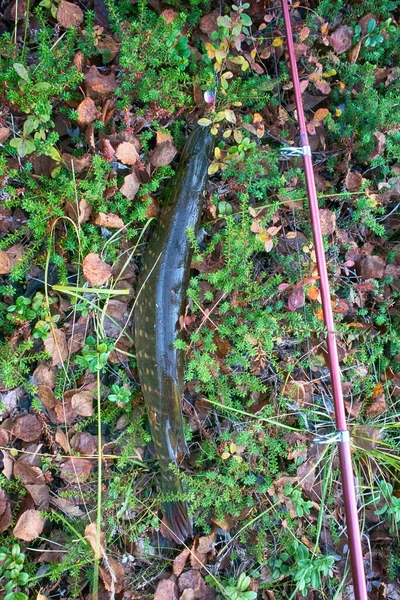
[0,0,400,600]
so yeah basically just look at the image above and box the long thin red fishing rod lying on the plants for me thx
[281,0,368,600]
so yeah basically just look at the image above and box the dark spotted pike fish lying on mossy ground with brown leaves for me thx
[135,127,213,541]
